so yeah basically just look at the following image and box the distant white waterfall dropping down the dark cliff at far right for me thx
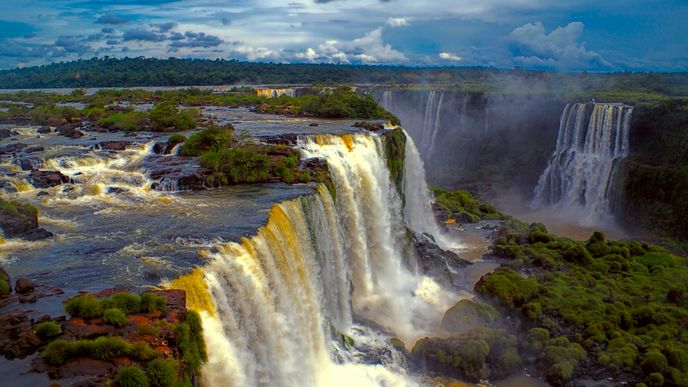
[531,103,633,223]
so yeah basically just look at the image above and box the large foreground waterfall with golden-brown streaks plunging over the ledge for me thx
[183,134,456,386]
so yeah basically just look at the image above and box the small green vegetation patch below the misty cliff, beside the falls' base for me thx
[432,188,504,223]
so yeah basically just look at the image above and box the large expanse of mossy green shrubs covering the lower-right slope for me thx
[482,220,688,386]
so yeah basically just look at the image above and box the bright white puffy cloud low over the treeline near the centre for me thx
[294,28,408,63]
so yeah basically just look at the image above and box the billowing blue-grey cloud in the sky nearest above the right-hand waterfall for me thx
[509,22,611,70]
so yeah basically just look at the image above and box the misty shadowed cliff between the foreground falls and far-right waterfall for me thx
[376,90,566,202]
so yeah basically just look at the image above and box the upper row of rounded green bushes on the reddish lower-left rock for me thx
[65,292,166,325]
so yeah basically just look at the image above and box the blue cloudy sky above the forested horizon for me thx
[0,0,688,72]
